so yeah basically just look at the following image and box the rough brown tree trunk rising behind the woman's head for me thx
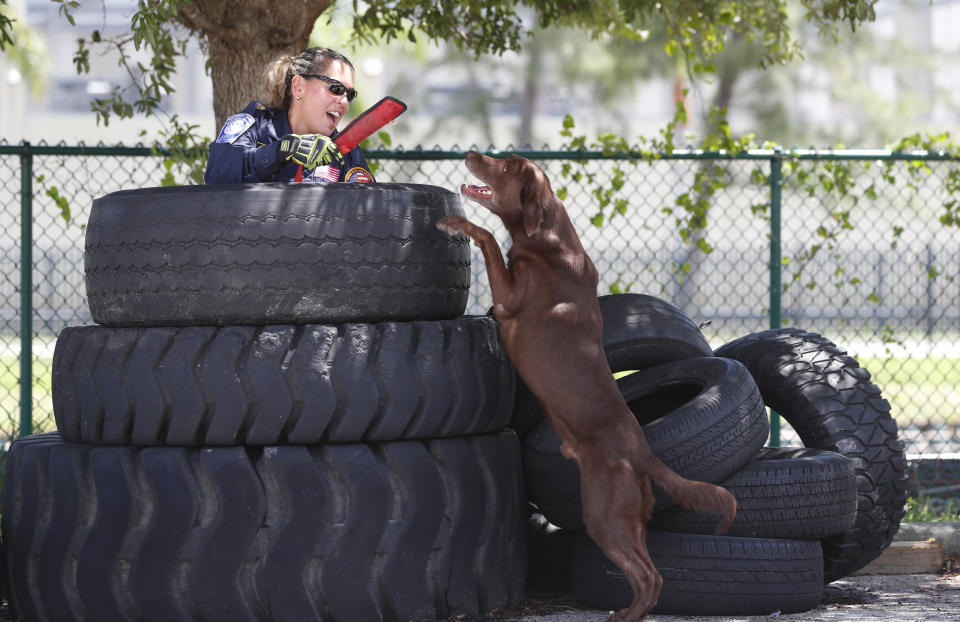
[180,0,333,128]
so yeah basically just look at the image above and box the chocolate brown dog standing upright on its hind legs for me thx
[437,151,737,622]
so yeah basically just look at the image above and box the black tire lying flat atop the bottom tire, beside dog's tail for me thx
[648,447,857,540]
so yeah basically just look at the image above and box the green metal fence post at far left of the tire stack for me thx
[20,141,33,436]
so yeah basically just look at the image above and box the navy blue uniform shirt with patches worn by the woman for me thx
[203,101,374,184]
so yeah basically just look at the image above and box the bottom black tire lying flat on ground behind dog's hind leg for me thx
[570,531,823,616]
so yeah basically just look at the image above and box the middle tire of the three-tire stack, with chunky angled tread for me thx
[52,317,515,446]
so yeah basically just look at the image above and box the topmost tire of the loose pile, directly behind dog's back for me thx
[510,294,713,438]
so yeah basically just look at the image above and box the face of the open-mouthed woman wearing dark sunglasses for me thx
[288,61,353,136]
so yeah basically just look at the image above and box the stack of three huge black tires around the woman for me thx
[3,184,526,622]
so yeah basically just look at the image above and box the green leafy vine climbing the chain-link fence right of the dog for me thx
[557,104,960,304]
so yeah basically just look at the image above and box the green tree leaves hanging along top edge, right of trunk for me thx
[353,0,876,68]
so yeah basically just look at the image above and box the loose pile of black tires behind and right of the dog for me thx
[514,294,907,615]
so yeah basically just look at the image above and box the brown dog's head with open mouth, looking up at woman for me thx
[460,151,556,237]
